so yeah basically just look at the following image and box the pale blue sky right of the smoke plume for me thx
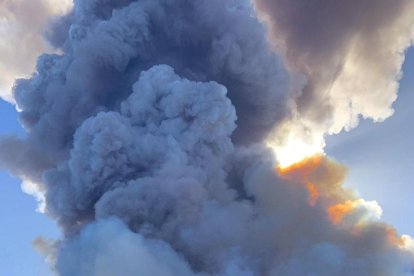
[325,49,414,236]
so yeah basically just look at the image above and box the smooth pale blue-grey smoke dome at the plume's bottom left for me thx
[57,219,195,276]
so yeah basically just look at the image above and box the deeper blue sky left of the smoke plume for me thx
[0,100,58,276]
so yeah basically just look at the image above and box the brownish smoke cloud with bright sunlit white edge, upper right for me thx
[253,0,414,164]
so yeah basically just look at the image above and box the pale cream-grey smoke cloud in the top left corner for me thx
[0,0,72,102]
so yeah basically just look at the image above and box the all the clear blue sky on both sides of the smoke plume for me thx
[0,40,414,276]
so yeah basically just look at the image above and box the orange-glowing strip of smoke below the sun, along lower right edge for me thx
[276,155,414,258]
